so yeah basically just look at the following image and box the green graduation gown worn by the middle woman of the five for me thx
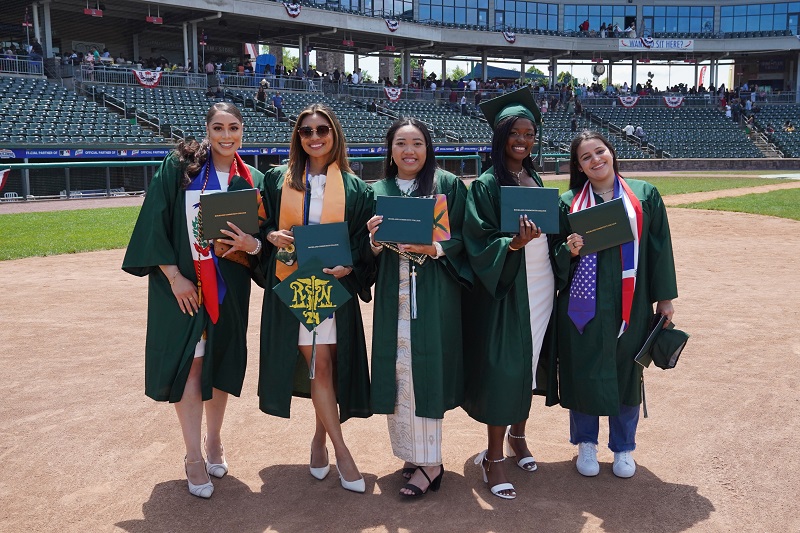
[372,170,472,418]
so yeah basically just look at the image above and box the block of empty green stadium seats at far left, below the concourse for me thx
[0,78,163,144]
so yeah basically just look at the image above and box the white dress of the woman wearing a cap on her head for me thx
[525,233,555,387]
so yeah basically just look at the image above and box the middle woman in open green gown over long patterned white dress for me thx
[367,118,472,497]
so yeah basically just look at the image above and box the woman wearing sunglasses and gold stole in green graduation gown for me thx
[258,104,373,492]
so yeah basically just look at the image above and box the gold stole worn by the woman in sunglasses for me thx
[275,163,345,281]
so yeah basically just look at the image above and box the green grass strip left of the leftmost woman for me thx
[0,207,140,261]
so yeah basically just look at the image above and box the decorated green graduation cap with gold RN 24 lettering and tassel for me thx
[273,263,351,379]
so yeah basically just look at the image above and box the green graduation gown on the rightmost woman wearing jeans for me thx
[556,180,678,416]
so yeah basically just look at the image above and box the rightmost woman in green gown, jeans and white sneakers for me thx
[557,131,678,478]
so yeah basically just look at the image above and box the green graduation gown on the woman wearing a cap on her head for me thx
[462,168,558,426]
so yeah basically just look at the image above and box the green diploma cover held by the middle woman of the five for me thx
[375,196,436,244]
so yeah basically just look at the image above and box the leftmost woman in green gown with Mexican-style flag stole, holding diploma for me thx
[122,102,263,498]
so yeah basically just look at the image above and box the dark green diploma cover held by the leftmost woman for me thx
[200,189,259,240]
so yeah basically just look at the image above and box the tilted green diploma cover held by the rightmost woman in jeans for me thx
[567,198,633,256]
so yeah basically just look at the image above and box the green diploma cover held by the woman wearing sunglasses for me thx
[292,222,353,268]
